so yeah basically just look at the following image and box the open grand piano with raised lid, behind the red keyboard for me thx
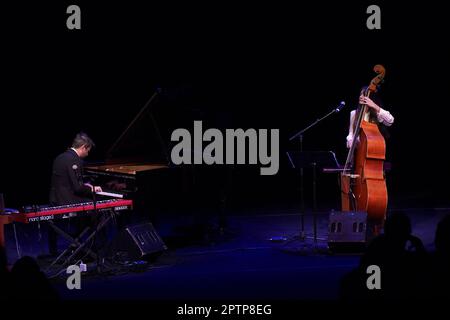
[84,89,184,217]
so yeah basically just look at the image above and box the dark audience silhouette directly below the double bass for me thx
[340,212,429,300]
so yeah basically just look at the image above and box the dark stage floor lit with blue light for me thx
[1,208,450,301]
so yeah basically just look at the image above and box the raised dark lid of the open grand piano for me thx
[103,88,170,166]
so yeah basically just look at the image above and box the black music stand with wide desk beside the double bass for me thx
[286,151,340,245]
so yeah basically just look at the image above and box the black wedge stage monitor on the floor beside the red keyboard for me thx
[115,222,167,260]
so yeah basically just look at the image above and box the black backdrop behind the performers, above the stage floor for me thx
[0,1,450,207]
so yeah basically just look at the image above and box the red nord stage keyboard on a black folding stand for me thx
[15,199,133,223]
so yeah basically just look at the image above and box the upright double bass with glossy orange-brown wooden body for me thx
[341,65,388,233]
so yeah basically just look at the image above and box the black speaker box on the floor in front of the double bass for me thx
[328,211,367,252]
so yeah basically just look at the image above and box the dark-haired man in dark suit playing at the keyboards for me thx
[49,133,102,255]
